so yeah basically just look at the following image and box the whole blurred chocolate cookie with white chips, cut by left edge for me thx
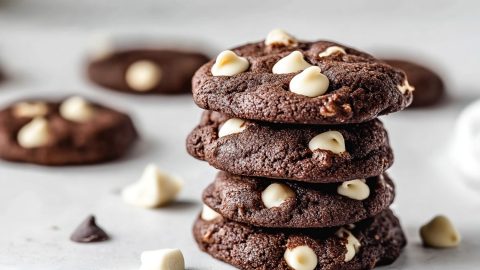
[0,97,138,165]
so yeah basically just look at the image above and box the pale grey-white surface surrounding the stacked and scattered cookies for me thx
[0,0,480,270]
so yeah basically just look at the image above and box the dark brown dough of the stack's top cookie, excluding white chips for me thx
[192,41,412,124]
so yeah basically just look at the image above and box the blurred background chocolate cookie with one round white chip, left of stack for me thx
[88,49,208,94]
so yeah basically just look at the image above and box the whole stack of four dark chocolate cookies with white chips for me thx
[187,30,413,270]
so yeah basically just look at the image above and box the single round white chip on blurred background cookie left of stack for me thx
[125,60,162,92]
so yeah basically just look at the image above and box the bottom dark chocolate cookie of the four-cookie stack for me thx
[193,210,406,270]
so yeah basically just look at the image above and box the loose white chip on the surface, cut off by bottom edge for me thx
[140,248,185,270]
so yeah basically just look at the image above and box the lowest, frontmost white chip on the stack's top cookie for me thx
[290,66,329,97]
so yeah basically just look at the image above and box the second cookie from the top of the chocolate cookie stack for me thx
[187,111,393,183]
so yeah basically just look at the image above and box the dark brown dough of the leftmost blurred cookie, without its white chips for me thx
[0,97,138,165]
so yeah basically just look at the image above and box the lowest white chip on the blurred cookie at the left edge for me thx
[17,117,50,148]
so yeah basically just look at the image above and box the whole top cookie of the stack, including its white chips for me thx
[192,30,413,124]
